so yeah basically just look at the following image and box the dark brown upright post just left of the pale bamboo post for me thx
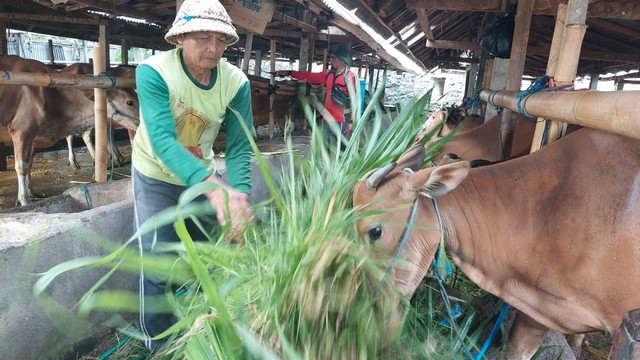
[499,0,535,159]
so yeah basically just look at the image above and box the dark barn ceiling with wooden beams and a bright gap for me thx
[0,0,640,76]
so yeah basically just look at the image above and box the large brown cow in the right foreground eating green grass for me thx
[353,128,640,359]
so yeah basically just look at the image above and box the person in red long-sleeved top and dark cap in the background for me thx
[276,45,356,145]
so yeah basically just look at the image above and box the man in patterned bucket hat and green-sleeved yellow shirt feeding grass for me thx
[131,0,253,351]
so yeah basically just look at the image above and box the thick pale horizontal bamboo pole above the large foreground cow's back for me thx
[480,90,640,139]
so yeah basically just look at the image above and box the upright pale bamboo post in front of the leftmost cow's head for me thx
[93,29,108,182]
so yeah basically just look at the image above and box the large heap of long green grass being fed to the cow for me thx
[34,79,502,359]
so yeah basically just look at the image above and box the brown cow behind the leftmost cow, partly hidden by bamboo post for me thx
[60,63,140,169]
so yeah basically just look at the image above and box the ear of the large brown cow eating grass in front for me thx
[409,161,471,198]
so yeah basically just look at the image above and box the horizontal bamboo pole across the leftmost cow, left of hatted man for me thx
[0,71,136,89]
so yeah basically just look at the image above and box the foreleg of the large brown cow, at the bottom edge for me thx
[498,311,549,360]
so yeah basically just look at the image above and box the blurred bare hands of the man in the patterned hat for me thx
[205,177,253,244]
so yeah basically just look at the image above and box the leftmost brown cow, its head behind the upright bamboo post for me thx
[0,56,138,205]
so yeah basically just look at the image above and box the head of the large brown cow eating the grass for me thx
[353,146,470,297]
